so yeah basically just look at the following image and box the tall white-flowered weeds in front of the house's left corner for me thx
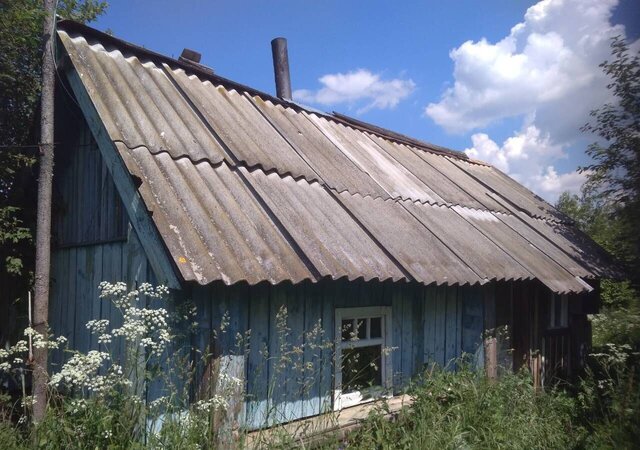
[0,282,218,450]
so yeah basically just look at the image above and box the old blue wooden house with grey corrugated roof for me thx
[50,21,612,427]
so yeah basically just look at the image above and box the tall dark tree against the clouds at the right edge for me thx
[581,36,640,287]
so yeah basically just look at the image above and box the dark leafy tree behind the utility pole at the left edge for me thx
[0,0,107,344]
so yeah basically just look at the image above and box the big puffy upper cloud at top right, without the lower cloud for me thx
[425,0,624,132]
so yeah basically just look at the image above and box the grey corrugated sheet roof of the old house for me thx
[58,22,613,292]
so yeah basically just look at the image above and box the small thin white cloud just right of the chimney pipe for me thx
[293,69,415,113]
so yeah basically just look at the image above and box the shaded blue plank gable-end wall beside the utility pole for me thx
[49,114,154,365]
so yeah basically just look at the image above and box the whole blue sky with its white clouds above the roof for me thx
[92,0,640,201]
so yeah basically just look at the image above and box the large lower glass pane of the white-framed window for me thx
[342,345,382,393]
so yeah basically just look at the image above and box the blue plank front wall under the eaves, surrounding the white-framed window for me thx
[193,280,487,427]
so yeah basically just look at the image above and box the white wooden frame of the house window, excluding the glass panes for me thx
[333,306,393,411]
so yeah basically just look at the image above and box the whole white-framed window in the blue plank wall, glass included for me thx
[333,306,392,410]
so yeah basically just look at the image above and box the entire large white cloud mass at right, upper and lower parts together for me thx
[425,0,636,201]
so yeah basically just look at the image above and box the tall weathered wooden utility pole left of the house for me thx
[33,0,56,422]
